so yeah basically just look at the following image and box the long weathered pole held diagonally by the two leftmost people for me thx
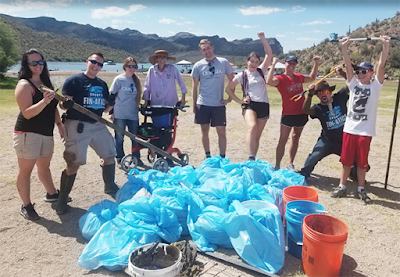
[38,84,186,166]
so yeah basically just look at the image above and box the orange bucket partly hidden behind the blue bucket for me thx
[282,186,318,223]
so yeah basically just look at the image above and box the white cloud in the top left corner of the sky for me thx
[0,0,71,14]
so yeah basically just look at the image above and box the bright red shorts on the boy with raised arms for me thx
[340,132,372,169]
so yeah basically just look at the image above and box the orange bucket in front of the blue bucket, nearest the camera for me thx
[302,214,348,277]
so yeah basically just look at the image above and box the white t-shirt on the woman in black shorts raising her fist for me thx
[233,69,269,103]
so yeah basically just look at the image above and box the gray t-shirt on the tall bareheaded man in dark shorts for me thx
[191,57,235,107]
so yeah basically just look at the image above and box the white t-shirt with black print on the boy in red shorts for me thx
[343,76,383,137]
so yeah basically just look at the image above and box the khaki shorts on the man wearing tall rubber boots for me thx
[64,119,116,166]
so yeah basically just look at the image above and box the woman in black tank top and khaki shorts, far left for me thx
[14,49,65,220]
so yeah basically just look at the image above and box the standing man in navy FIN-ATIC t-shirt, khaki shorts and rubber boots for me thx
[56,53,118,214]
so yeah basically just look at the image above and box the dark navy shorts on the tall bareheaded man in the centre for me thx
[194,105,226,127]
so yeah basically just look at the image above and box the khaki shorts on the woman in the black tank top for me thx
[13,133,54,160]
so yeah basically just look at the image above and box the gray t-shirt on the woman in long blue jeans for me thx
[110,74,139,120]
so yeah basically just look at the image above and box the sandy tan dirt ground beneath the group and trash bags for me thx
[0,72,400,277]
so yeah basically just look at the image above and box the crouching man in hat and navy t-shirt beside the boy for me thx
[299,78,349,178]
